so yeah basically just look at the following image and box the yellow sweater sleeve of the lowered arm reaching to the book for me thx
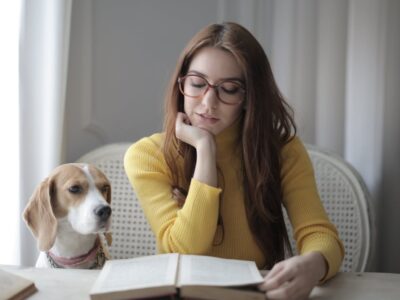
[281,137,344,281]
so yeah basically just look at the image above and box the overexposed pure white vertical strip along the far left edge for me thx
[0,0,21,264]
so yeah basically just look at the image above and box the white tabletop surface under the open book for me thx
[0,266,400,300]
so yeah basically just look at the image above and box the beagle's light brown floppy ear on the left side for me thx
[23,177,57,251]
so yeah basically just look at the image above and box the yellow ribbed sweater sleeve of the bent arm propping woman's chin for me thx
[124,135,221,254]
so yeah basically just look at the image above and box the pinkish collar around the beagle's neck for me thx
[46,238,106,269]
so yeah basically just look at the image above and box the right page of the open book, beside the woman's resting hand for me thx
[178,255,263,286]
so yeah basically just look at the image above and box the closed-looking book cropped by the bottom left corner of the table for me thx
[0,269,37,300]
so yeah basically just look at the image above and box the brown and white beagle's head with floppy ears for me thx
[23,164,111,251]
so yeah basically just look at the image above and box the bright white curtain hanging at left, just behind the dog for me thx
[19,0,72,265]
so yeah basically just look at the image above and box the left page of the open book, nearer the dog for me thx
[91,254,179,293]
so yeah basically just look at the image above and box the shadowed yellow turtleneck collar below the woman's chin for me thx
[215,117,243,160]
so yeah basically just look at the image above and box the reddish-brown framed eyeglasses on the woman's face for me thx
[178,74,246,105]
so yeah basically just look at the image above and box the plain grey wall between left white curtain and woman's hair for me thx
[66,0,218,161]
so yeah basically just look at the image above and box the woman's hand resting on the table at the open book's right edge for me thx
[259,252,327,300]
